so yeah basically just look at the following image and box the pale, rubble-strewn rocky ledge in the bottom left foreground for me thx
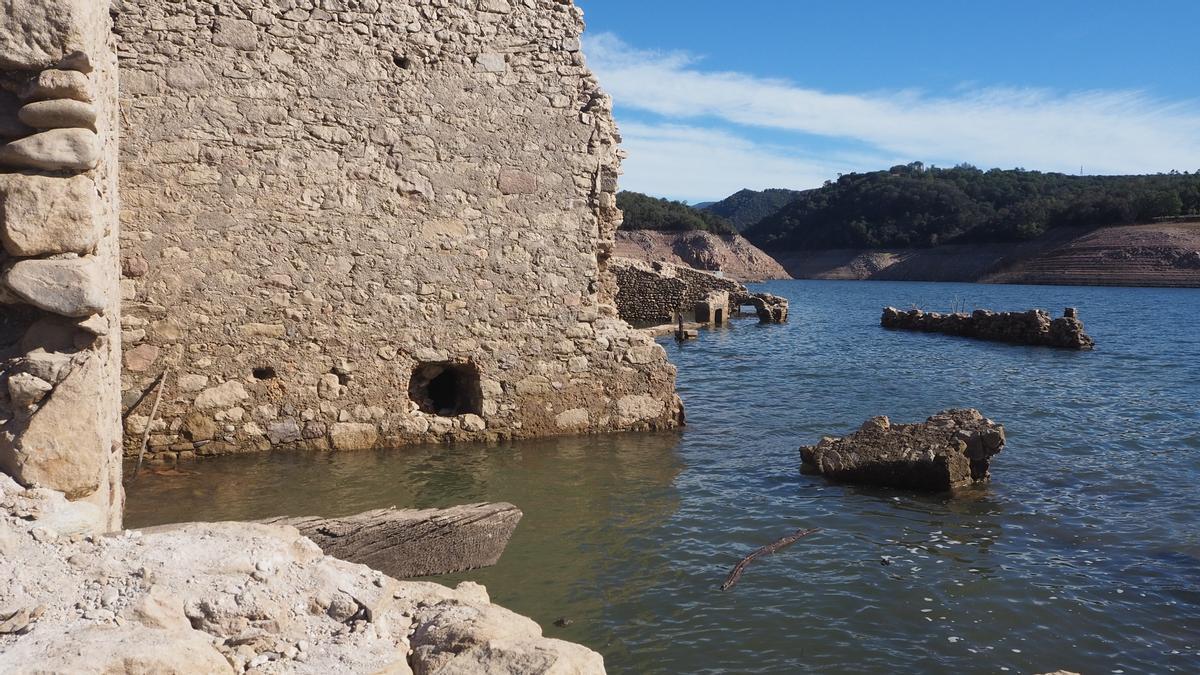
[0,474,604,675]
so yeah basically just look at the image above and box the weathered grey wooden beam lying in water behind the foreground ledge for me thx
[259,502,524,579]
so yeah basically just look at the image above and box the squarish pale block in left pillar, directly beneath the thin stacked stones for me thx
[0,174,101,258]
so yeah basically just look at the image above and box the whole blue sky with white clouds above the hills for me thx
[577,0,1200,202]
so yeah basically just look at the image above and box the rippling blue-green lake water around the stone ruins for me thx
[126,281,1200,674]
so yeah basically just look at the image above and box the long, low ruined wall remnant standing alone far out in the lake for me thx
[880,307,1096,350]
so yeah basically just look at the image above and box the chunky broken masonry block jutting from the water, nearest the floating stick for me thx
[800,410,1004,492]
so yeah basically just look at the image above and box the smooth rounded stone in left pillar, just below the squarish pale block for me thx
[5,257,108,318]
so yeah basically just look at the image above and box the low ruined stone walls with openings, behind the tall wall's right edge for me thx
[610,258,788,325]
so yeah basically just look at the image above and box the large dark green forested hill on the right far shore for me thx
[734,162,1200,251]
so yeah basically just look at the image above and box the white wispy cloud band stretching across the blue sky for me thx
[586,34,1200,196]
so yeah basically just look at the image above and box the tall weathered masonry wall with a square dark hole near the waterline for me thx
[115,0,680,459]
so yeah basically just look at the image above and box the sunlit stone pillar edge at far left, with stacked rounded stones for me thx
[0,0,124,531]
